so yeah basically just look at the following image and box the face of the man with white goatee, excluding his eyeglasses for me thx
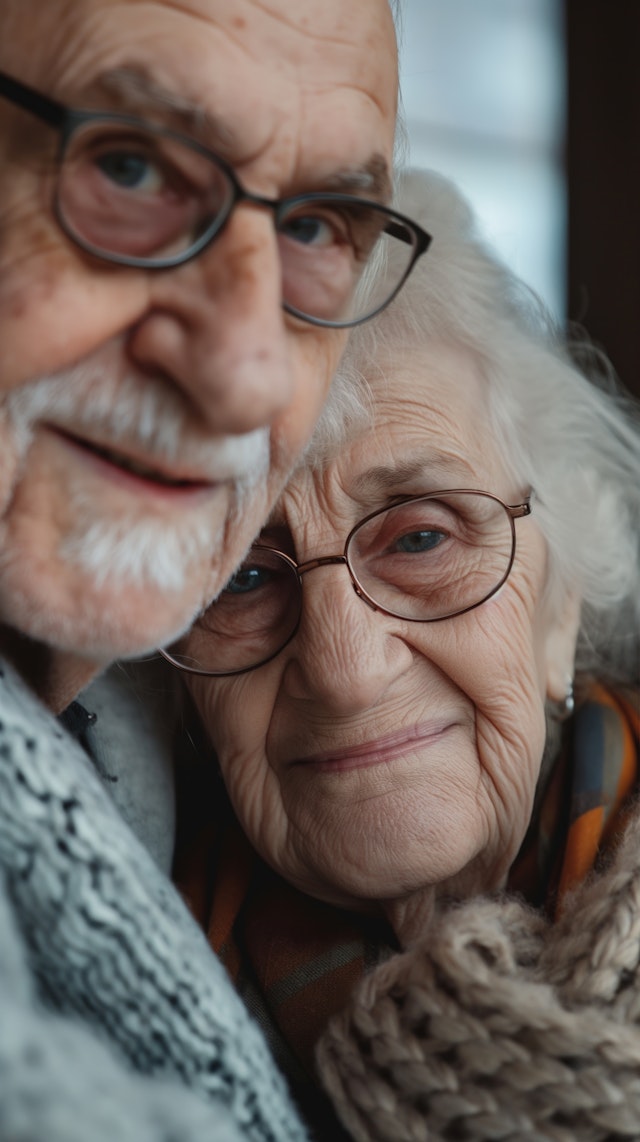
[0,0,397,661]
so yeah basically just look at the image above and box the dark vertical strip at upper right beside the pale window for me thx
[565,0,640,396]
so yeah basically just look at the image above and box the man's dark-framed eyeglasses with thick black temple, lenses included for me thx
[0,73,431,328]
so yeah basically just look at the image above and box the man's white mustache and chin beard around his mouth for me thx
[0,360,270,592]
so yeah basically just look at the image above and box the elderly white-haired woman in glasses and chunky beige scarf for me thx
[165,175,640,1142]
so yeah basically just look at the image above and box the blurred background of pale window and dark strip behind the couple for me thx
[401,0,640,395]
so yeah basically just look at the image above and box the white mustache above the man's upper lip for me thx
[5,362,270,485]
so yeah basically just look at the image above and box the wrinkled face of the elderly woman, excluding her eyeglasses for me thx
[190,345,574,922]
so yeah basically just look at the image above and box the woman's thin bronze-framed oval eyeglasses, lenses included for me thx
[161,489,531,676]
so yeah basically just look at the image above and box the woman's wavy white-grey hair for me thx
[306,171,640,683]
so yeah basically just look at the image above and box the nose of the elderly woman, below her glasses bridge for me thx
[283,565,413,717]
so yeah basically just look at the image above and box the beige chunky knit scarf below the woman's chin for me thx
[318,794,640,1142]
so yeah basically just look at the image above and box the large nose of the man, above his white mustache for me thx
[129,206,295,434]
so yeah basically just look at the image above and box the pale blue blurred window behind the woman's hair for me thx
[400,0,567,320]
